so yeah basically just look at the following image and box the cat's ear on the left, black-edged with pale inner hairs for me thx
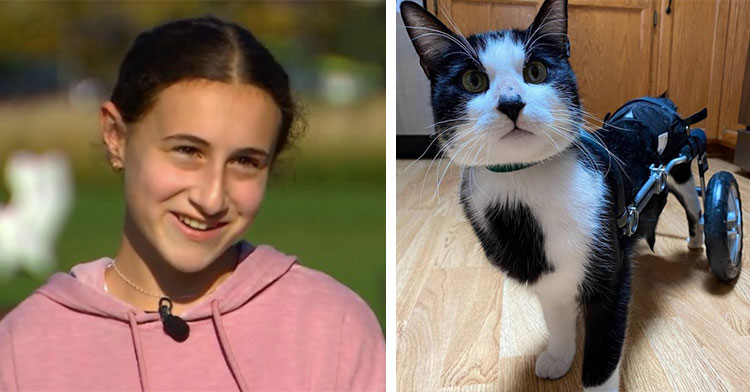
[401,1,463,79]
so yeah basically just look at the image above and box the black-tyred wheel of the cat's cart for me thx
[703,171,742,282]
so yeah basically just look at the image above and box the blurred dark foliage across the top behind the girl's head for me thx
[0,1,386,98]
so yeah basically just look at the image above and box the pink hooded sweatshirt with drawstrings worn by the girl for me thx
[0,242,385,391]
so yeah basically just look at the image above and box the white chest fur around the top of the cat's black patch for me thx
[463,154,605,283]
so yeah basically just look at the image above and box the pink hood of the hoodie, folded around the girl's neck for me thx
[37,241,297,324]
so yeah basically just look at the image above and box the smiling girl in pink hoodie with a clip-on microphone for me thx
[0,17,385,391]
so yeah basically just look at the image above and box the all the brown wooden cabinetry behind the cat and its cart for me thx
[426,0,750,146]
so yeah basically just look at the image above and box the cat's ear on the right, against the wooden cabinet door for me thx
[527,0,570,57]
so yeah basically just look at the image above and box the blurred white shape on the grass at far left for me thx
[0,151,73,278]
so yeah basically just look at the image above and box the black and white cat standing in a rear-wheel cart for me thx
[401,0,702,390]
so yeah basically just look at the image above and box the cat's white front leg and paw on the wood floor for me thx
[535,291,578,379]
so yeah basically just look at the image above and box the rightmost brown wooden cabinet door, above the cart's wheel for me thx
[655,0,750,147]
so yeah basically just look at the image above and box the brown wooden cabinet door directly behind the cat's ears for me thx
[426,0,656,125]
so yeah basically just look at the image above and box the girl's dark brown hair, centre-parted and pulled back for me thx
[111,16,296,158]
